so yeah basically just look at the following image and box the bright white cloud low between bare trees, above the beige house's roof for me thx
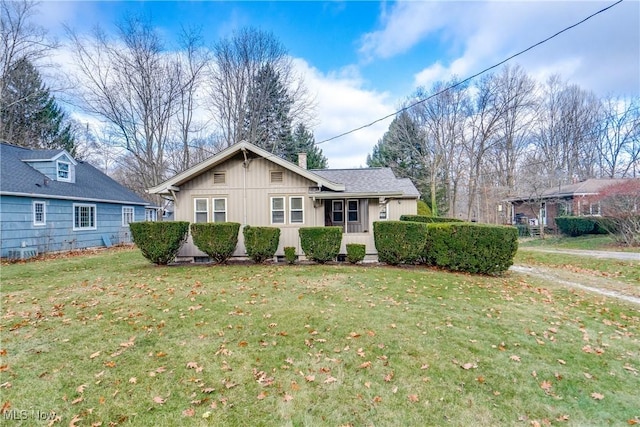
[294,59,394,169]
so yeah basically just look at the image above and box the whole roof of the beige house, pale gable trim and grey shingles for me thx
[147,141,420,198]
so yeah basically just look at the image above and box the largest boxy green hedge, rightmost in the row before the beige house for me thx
[424,223,518,274]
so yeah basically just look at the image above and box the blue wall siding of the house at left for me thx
[0,196,145,257]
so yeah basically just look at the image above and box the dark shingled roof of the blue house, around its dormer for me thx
[0,142,149,205]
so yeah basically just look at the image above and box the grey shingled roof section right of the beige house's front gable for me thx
[311,168,420,197]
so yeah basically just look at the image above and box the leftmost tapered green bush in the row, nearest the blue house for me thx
[129,221,189,265]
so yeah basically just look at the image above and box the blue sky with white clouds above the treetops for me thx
[37,0,640,167]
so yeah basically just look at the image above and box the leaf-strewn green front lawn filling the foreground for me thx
[0,249,640,426]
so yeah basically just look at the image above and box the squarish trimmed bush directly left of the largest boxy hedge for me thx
[373,221,427,265]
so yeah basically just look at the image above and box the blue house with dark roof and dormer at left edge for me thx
[0,142,150,258]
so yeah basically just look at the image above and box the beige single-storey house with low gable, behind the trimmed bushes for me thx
[148,142,419,260]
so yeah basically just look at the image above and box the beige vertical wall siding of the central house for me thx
[174,154,417,259]
